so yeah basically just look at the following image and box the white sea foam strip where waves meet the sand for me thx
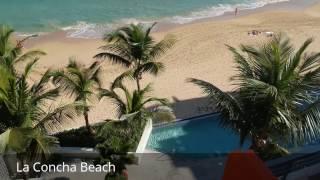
[23,0,289,39]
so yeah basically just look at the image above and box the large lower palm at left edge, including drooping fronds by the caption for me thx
[0,59,75,179]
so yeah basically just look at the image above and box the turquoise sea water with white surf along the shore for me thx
[0,0,286,37]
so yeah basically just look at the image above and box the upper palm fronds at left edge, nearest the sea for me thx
[0,25,45,73]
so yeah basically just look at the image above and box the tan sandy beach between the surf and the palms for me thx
[22,1,320,131]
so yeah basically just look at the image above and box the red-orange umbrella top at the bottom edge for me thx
[223,150,277,180]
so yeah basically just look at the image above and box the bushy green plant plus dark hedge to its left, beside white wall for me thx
[54,114,146,179]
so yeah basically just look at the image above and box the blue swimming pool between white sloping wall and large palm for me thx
[147,114,249,154]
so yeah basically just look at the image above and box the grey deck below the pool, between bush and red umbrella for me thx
[128,151,226,180]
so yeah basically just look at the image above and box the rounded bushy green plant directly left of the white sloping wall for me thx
[96,114,146,178]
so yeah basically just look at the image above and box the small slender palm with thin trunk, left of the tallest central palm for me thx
[53,59,101,134]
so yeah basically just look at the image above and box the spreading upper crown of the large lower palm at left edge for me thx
[0,60,74,132]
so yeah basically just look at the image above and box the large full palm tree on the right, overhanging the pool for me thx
[188,35,320,156]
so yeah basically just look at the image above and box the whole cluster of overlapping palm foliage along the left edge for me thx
[0,26,80,178]
